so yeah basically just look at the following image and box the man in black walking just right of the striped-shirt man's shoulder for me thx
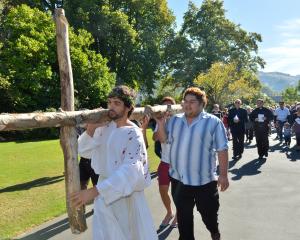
[228,99,248,160]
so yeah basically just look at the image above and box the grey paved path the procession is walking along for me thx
[17,135,300,240]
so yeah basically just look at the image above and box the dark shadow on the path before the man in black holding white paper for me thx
[229,158,266,181]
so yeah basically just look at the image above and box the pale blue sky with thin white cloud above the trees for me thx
[167,0,300,76]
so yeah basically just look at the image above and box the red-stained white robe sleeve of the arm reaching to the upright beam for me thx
[96,129,151,204]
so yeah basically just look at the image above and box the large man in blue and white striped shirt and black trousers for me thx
[158,87,229,240]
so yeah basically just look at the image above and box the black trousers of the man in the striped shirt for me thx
[171,178,219,240]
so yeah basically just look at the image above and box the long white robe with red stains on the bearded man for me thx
[78,122,158,240]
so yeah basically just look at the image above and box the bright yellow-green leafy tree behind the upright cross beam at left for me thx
[0,5,115,112]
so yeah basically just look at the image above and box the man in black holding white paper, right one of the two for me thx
[250,99,273,159]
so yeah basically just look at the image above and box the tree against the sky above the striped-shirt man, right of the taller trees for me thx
[167,0,264,87]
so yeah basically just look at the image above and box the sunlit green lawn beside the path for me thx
[0,130,159,239]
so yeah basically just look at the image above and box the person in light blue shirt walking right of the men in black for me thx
[274,101,290,142]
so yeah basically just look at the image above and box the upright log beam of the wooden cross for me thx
[55,8,87,234]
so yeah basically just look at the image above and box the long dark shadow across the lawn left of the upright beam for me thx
[0,175,64,193]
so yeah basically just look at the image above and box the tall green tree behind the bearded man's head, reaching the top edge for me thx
[64,0,175,93]
